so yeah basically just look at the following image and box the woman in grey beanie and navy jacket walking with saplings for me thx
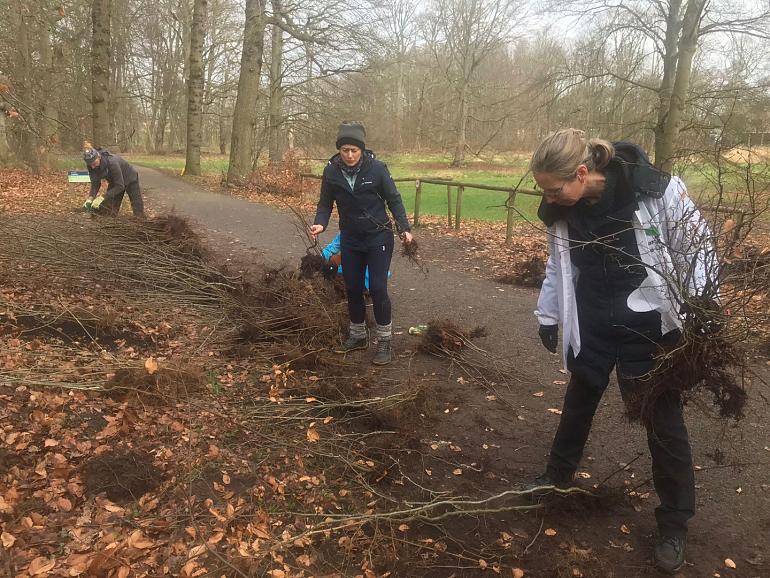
[309,122,412,365]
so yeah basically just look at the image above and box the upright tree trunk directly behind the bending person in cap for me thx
[91,0,112,147]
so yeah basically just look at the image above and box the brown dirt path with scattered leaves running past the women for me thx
[140,168,770,577]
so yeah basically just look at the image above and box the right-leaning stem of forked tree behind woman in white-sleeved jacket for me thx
[655,0,707,171]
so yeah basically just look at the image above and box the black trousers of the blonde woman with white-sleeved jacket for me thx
[547,373,695,536]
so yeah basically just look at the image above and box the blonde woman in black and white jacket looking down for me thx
[530,129,716,572]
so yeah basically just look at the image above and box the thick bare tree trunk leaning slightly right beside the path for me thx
[227,0,266,185]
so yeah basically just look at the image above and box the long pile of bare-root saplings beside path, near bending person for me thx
[0,215,343,385]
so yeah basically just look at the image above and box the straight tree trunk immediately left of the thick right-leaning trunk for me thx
[183,0,208,176]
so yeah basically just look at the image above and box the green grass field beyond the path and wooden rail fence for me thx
[59,154,770,221]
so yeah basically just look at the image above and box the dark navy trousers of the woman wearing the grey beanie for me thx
[341,235,393,325]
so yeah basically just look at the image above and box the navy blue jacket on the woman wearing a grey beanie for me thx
[314,150,411,245]
